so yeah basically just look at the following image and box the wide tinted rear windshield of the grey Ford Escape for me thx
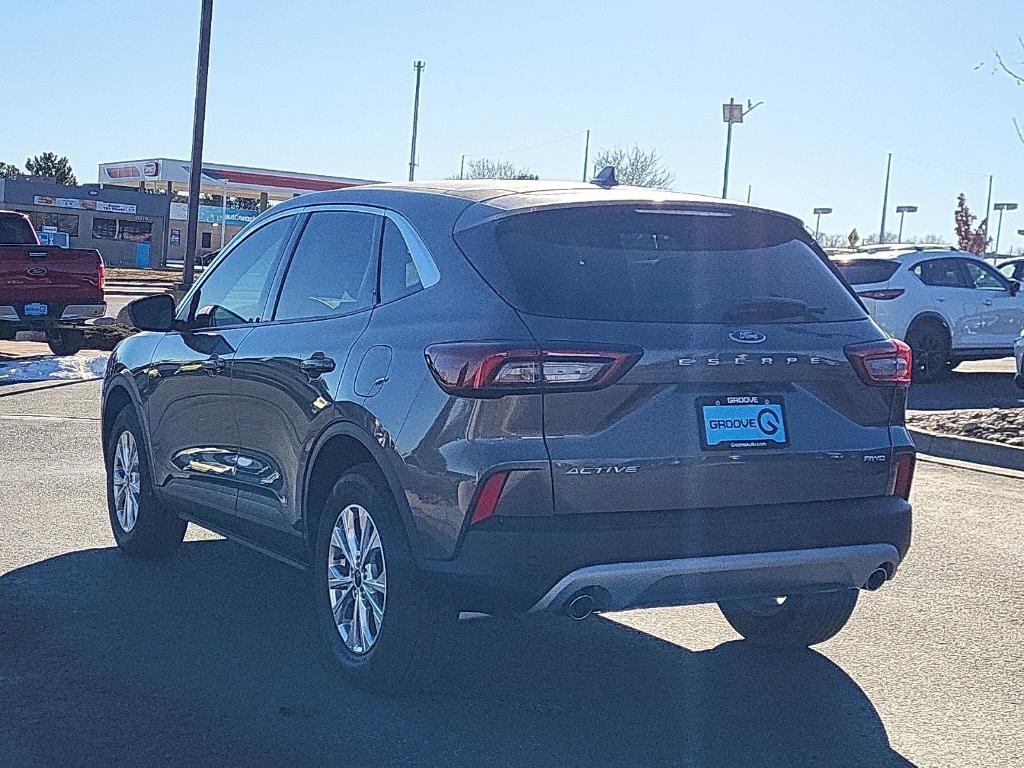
[456,206,864,323]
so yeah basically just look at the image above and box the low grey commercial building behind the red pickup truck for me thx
[0,176,170,266]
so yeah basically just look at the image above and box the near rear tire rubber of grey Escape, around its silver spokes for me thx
[313,464,458,693]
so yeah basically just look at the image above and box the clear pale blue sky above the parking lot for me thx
[6,0,1024,244]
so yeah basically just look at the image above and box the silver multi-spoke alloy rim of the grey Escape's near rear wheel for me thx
[327,504,387,654]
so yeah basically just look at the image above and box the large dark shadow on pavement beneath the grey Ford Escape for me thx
[0,541,911,768]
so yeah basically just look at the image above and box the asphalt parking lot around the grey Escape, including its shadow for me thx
[0,382,1024,767]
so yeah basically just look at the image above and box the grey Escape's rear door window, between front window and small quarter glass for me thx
[274,211,381,319]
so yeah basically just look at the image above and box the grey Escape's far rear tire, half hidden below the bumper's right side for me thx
[718,590,858,648]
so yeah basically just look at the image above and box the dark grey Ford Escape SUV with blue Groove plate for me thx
[101,175,914,687]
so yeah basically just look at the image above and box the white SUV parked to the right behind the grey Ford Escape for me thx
[835,247,1024,381]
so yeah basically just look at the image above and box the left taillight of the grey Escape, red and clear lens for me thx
[425,342,642,397]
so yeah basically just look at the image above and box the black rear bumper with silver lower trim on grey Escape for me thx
[421,497,911,613]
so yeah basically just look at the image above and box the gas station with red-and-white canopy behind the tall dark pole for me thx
[98,158,374,262]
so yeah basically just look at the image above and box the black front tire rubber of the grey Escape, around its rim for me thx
[106,408,188,557]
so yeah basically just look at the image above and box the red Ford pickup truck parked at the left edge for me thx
[0,211,106,354]
